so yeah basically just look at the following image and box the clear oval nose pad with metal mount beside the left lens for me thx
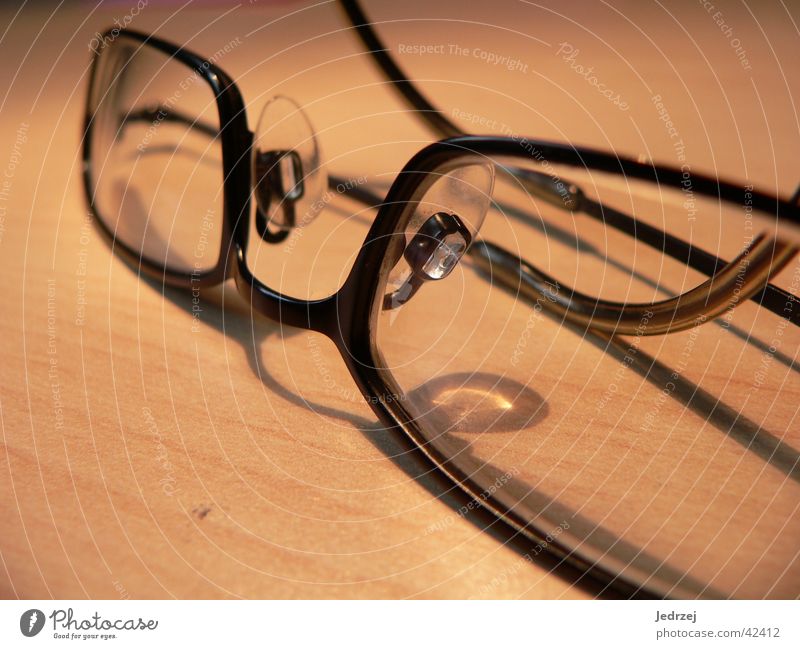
[252,96,328,243]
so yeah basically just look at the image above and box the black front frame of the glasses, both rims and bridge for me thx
[83,29,800,595]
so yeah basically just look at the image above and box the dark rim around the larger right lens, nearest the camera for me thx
[334,136,800,597]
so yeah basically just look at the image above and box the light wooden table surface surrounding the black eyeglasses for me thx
[0,0,800,598]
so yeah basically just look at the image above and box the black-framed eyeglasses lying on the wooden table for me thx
[84,15,800,595]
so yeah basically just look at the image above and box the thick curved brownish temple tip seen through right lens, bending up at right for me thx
[469,235,797,336]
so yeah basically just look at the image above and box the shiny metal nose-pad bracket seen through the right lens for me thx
[384,212,472,309]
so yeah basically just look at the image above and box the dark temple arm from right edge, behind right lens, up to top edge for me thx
[340,0,800,325]
